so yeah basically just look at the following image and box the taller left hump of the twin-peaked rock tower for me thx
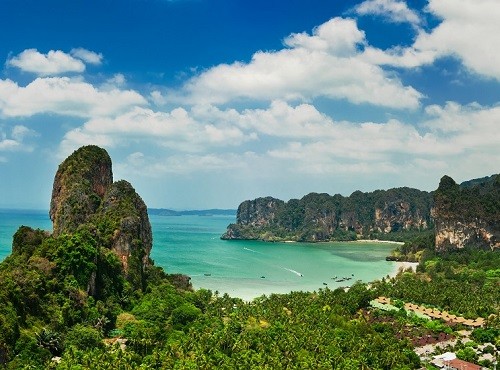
[49,145,113,236]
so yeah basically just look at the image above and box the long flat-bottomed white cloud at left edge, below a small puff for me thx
[0,77,147,118]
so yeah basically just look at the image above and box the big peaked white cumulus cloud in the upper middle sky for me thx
[170,18,422,108]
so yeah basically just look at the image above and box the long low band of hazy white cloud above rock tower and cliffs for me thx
[56,95,500,182]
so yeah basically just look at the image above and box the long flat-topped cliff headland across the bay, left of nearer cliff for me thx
[222,188,433,241]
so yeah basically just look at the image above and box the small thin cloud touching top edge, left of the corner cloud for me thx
[355,0,421,25]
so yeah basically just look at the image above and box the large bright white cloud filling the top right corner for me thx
[358,0,500,80]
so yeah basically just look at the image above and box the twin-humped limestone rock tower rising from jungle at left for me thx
[50,146,153,294]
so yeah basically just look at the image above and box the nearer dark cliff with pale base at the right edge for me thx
[432,175,500,251]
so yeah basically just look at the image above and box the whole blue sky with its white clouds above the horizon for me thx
[0,0,500,209]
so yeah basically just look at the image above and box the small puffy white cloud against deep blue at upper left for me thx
[7,49,85,76]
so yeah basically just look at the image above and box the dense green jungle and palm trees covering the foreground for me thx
[0,227,500,369]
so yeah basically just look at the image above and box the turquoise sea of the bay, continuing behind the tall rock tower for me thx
[0,210,395,299]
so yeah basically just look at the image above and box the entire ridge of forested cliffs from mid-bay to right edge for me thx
[221,175,500,250]
